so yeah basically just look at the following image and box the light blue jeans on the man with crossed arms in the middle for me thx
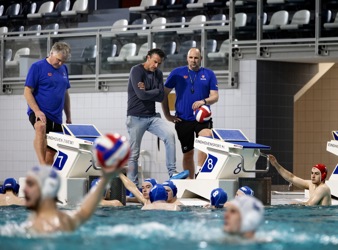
[126,116,176,186]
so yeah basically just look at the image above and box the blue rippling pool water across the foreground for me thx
[0,205,338,250]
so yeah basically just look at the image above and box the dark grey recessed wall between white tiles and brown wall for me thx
[257,61,318,185]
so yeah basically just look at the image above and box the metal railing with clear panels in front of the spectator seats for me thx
[0,0,338,94]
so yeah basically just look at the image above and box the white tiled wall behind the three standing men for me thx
[0,61,256,185]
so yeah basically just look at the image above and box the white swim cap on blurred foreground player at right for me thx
[230,195,264,233]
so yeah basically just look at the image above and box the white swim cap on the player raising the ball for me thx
[27,166,61,199]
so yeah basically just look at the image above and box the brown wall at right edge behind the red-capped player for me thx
[294,64,338,179]
